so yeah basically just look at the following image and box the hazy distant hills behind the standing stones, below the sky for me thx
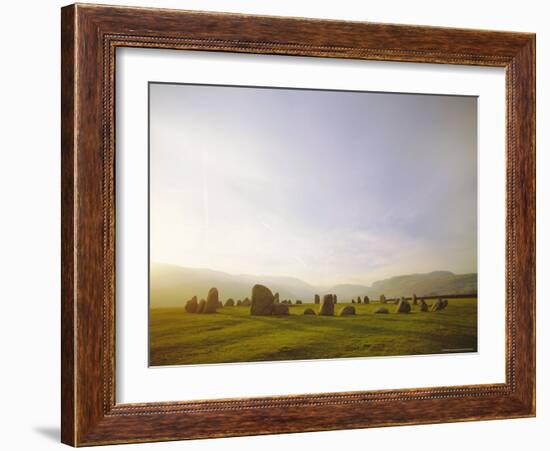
[150,264,477,307]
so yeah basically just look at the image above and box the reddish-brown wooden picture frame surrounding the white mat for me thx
[61,4,535,446]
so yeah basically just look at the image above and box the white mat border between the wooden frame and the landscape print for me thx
[116,48,505,403]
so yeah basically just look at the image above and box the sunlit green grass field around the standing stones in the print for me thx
[149,298,477,366]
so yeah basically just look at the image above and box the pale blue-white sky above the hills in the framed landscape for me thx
[150,84,477,285]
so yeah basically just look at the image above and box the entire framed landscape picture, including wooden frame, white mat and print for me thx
[61,4,535,446]
